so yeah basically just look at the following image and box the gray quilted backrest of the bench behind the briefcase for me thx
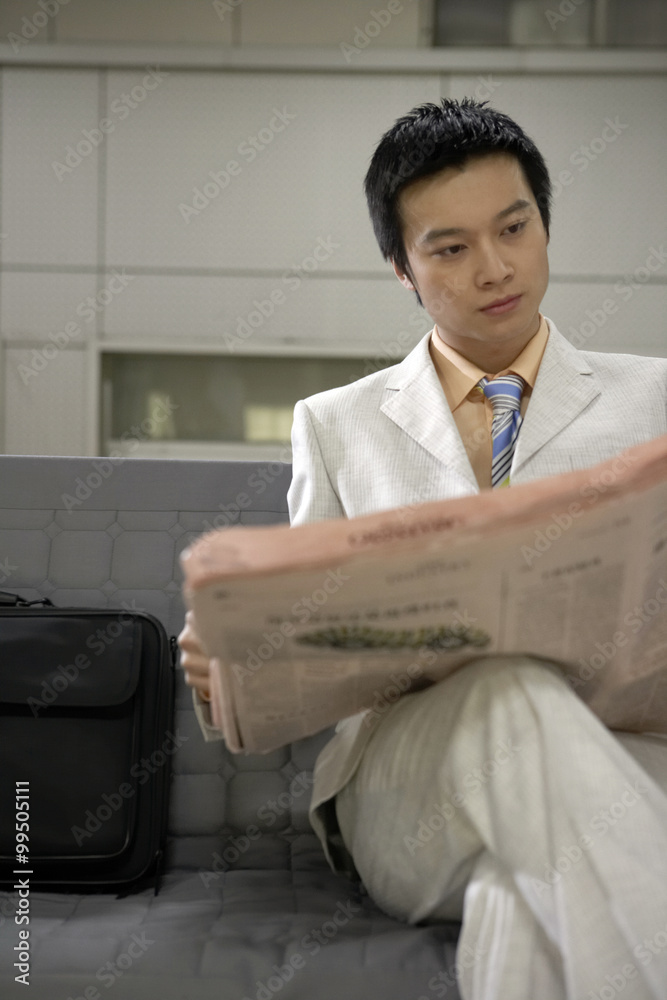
[0,456,328,873]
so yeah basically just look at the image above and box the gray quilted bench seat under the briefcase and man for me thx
[0,868,458,1000]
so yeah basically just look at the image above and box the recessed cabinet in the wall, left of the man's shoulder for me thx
[100,351,391,460]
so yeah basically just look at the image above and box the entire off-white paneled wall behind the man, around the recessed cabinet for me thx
[0,55,667,454]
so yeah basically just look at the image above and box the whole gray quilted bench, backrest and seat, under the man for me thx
[0,456,459,1000]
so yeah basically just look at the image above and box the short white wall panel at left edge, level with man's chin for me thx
[0,271,96,342]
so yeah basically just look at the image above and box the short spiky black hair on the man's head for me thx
[364,97,551,274]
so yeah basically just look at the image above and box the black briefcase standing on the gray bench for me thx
[0,593,176,893]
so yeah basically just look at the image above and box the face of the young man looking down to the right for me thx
[394,153,549,372]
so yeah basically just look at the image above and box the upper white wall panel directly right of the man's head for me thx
[450,75,667,275]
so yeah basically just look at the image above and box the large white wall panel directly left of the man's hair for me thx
[106,72,439,270]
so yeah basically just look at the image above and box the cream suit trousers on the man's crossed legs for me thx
[336,657,667,1000]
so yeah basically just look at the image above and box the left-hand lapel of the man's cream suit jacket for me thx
[380,332,478,491]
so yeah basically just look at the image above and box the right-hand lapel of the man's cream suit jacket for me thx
[512,321,601,476]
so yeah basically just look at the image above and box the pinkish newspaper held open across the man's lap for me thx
[181,435,667,752]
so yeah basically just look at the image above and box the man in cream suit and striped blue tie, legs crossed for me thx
[184,100,667,1000]
